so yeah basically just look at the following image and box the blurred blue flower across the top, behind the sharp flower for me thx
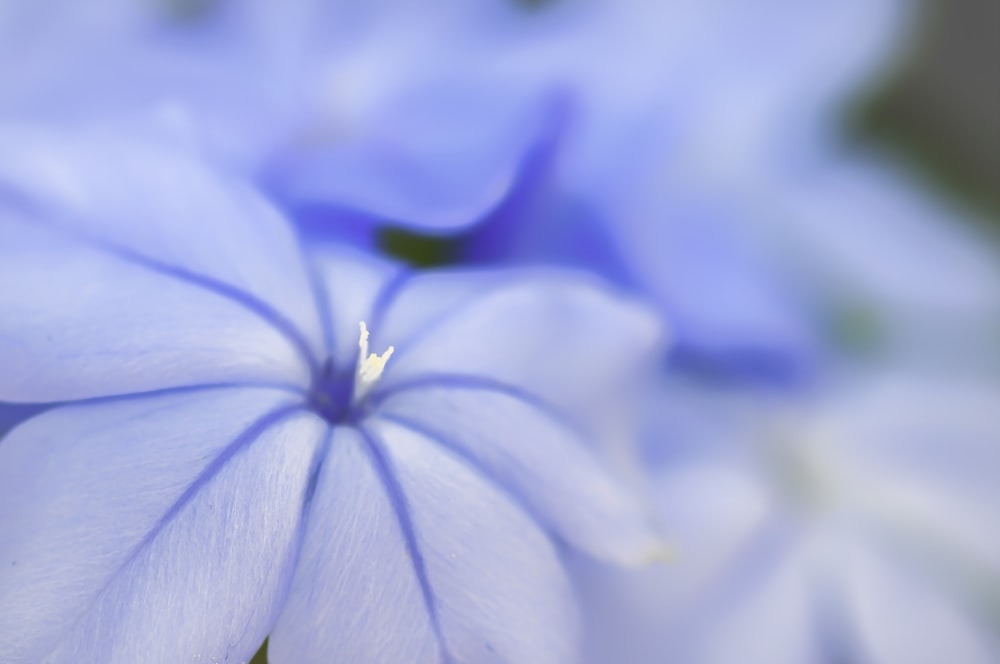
[0,0,906,379]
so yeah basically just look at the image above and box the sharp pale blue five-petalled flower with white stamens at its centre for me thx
[0,127,672,664]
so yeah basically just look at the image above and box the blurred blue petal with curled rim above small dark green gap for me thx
[265,81,558,232]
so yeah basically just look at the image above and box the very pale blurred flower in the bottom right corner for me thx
[575,371,1000,664]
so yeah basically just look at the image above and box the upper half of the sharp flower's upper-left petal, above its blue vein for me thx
[0,126,322,368]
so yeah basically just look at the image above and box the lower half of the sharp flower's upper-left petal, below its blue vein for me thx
[0,220,309,402]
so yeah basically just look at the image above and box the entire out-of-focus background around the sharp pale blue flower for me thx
[0,0,1000,664]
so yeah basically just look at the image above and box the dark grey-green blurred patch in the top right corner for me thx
[847,0,1000,228]
